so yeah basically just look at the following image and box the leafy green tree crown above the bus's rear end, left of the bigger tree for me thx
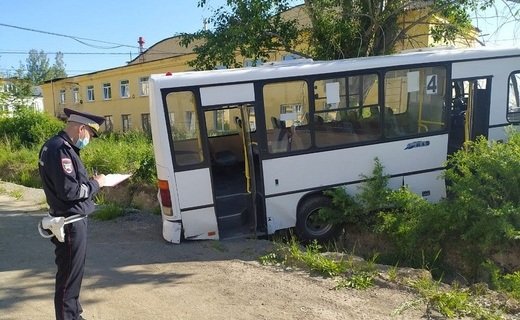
[181,0,298,70]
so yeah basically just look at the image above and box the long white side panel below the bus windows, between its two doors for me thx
[262,134,448,199]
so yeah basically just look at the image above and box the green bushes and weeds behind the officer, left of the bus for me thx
[0,115,157,191]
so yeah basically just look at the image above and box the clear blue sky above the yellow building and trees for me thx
[0,0,520,76]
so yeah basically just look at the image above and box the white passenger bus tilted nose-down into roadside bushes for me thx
[150,48,520,243]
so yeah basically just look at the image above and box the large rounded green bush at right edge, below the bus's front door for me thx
[445,133,520,253]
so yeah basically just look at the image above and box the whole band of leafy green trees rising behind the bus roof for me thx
[181,0,518,69]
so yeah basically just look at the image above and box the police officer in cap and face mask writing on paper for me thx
[39,108,105,320]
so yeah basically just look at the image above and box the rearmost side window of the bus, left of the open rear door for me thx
[166,91,204,166]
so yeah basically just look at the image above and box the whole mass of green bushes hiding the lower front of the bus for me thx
[322,132,520,279]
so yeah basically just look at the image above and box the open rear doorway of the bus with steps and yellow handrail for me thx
[204,104,258,239]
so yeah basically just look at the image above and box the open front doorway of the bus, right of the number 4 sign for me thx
[448,78,491,154]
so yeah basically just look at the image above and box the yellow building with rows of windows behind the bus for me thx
[42,5,478,132]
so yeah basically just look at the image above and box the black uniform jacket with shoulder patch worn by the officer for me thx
[38,131,99,217]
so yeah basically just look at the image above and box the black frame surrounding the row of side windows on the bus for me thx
[161,61,454,165]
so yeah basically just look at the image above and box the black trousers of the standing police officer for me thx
[52,219,87,320]
